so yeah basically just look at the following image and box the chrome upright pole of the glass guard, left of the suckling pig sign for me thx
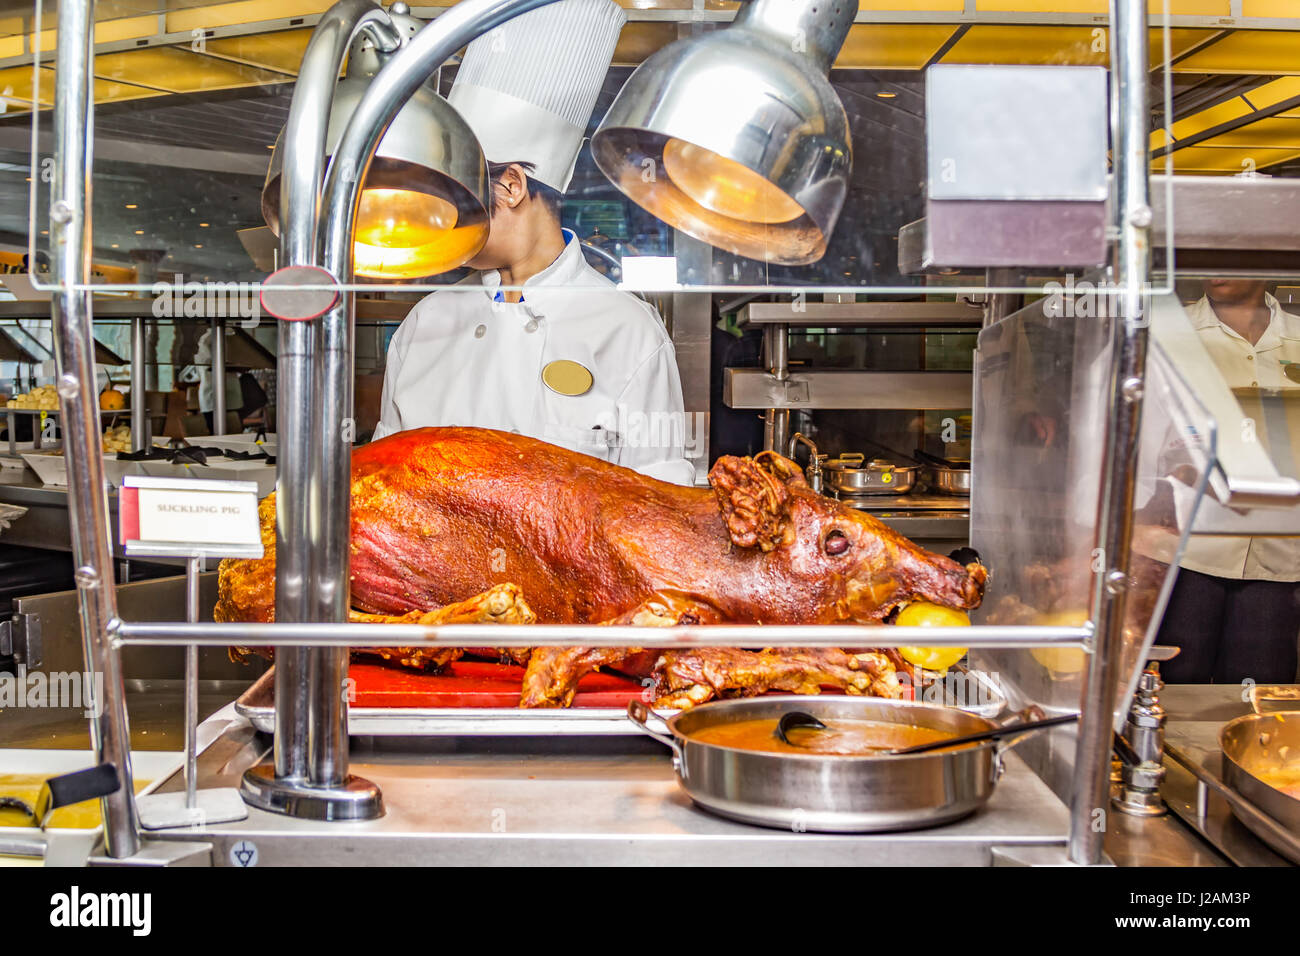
[49,0,139,857]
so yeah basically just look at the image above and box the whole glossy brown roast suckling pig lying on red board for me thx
[216,428,985,706]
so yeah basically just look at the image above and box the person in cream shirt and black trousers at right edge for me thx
[1156,278,1300,684]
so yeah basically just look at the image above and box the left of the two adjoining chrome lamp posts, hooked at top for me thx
[243,0,400,809]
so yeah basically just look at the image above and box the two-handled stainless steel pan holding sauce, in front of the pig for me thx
[628,696,1041,832]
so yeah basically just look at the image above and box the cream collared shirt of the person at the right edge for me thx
[1182,295,1300,581]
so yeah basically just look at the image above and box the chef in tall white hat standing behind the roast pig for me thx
[374,0,696,484]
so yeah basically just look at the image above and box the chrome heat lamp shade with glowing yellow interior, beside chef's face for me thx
[261,17,490,280]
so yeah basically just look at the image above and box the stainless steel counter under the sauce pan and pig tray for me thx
[137,721,1069,866]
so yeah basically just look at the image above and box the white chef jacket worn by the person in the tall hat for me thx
[374,230,696,485]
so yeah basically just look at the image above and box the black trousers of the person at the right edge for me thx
[1156,567,1300,684]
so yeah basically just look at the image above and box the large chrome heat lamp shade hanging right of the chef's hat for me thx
[592,0,857,265]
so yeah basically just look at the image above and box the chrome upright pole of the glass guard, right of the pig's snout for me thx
[1069,0,1152,865]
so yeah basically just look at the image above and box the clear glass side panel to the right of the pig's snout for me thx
[971,291,1216,793]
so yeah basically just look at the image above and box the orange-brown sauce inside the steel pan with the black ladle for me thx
[690,717,957,757]
